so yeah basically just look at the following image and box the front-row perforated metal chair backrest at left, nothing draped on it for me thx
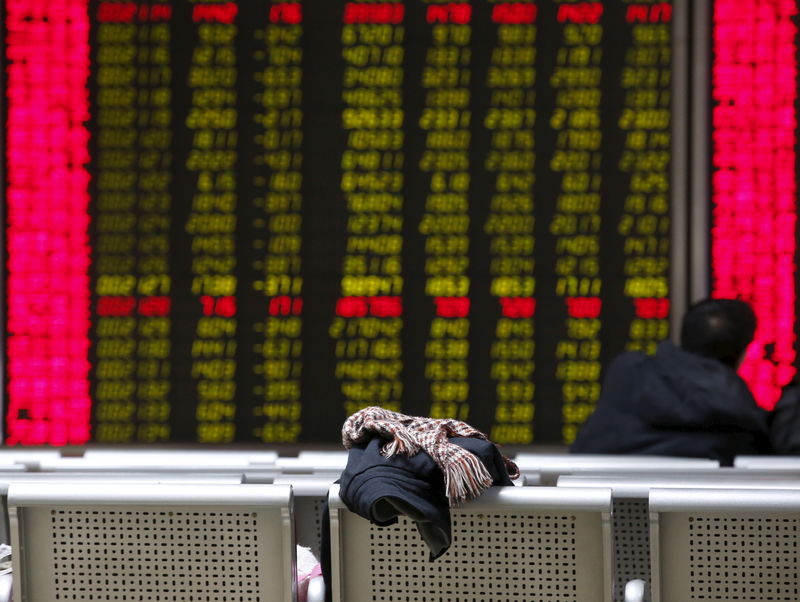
[8,483,295,602]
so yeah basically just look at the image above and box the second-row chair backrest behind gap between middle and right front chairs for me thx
[558,469,800,602]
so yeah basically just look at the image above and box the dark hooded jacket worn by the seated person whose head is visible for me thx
[570,342,772,465]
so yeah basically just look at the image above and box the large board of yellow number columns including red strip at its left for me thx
[5,0,674,444]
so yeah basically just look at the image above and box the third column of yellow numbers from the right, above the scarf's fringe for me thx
[484,3,537,444]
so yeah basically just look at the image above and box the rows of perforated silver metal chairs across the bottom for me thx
[0,454,800,602]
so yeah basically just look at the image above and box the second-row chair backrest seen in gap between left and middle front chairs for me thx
[276,475,336,558]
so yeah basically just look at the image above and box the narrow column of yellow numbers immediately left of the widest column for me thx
[253,2,303,442]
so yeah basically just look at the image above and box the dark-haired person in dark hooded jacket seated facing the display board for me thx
[570,299,788,466]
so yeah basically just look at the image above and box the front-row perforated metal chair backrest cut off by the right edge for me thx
[650,489,800,602]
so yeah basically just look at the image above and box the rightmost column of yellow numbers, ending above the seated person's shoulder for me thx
[617,2,672,354]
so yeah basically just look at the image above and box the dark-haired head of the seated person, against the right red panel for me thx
[681,299,756,369]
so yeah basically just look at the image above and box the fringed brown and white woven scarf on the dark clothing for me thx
[342,406,519,507]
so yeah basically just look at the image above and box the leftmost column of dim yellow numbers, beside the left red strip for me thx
[94,16,139,443]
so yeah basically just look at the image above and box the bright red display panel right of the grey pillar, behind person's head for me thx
[710,0,798,410]
